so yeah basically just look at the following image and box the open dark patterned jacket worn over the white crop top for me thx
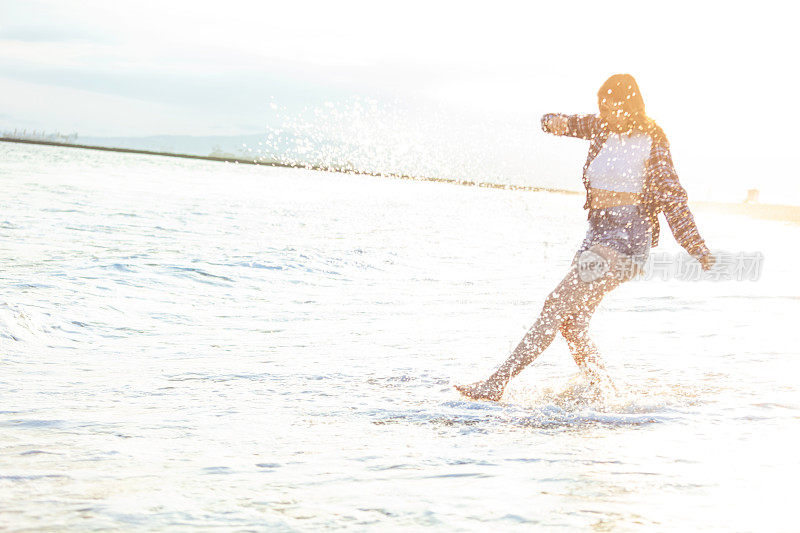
[542,113,710,261]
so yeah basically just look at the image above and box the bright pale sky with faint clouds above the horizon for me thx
[0,0,800,203]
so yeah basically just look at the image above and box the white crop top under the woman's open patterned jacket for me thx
[586,131,652,193]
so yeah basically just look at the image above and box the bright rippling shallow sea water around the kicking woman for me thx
[0,143,800,531]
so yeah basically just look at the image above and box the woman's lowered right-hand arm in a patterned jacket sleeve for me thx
[649,143,715,270]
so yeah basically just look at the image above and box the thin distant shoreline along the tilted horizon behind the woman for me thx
[0,137,800,224]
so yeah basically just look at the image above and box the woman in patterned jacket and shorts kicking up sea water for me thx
[456,74,714,401]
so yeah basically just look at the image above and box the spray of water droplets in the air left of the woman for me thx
[252,97,564,190]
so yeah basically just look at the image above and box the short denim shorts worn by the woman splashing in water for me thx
[578,205,652,265]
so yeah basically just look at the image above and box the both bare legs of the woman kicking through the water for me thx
[456,264,621,401]
